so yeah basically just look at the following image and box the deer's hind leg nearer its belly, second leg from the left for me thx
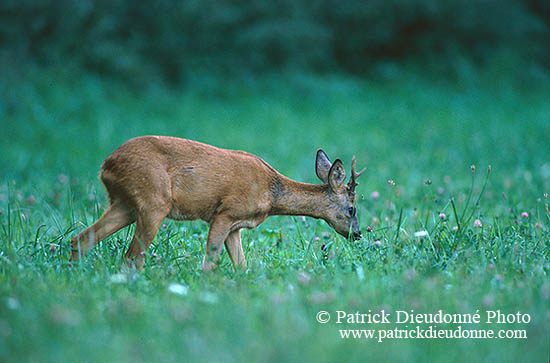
[125,205,171,269]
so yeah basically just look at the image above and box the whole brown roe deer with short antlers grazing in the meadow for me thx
[71,136,365,271]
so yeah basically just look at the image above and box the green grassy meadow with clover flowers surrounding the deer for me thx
[0,69,550,362]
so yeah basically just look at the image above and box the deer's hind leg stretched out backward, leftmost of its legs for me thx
[70,201,134,261]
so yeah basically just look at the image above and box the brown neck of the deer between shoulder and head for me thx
[270,175,327,218]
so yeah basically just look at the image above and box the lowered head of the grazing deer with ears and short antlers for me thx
[315,150,365,240]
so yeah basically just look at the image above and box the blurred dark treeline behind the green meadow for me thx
[0,0,550,82]
